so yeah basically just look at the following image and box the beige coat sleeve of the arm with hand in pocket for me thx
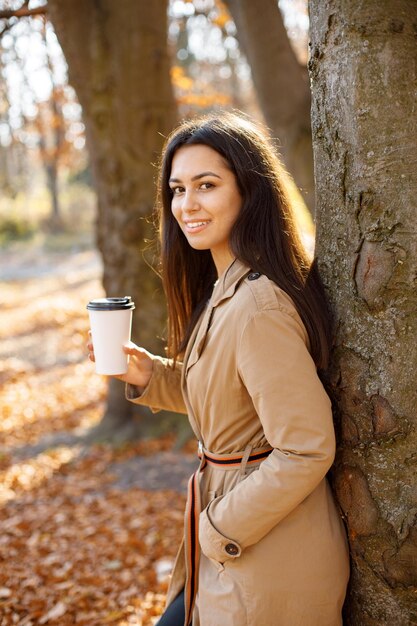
[199,308,335,562]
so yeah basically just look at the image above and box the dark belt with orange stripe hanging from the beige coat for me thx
[184,442,273,626]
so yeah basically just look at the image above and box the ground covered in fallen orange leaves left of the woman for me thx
[0,246,194,626]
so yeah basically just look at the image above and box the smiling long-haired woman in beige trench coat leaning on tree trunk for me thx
[89,113,349,626]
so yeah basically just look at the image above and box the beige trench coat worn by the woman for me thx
[126,260,349,626]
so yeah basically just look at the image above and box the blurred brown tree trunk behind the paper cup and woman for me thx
[48,0,176,434]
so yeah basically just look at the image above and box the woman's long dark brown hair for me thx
[158,113,330,368]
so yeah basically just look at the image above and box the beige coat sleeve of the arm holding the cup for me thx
[126,356,187,413]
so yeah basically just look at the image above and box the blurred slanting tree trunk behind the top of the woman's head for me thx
[225,0,314,214]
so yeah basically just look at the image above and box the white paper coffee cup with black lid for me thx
[87,296,135,376]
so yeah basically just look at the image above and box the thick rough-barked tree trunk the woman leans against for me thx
[310,0,417,626]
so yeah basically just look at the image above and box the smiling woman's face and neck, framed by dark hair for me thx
[169,144,242,276]
